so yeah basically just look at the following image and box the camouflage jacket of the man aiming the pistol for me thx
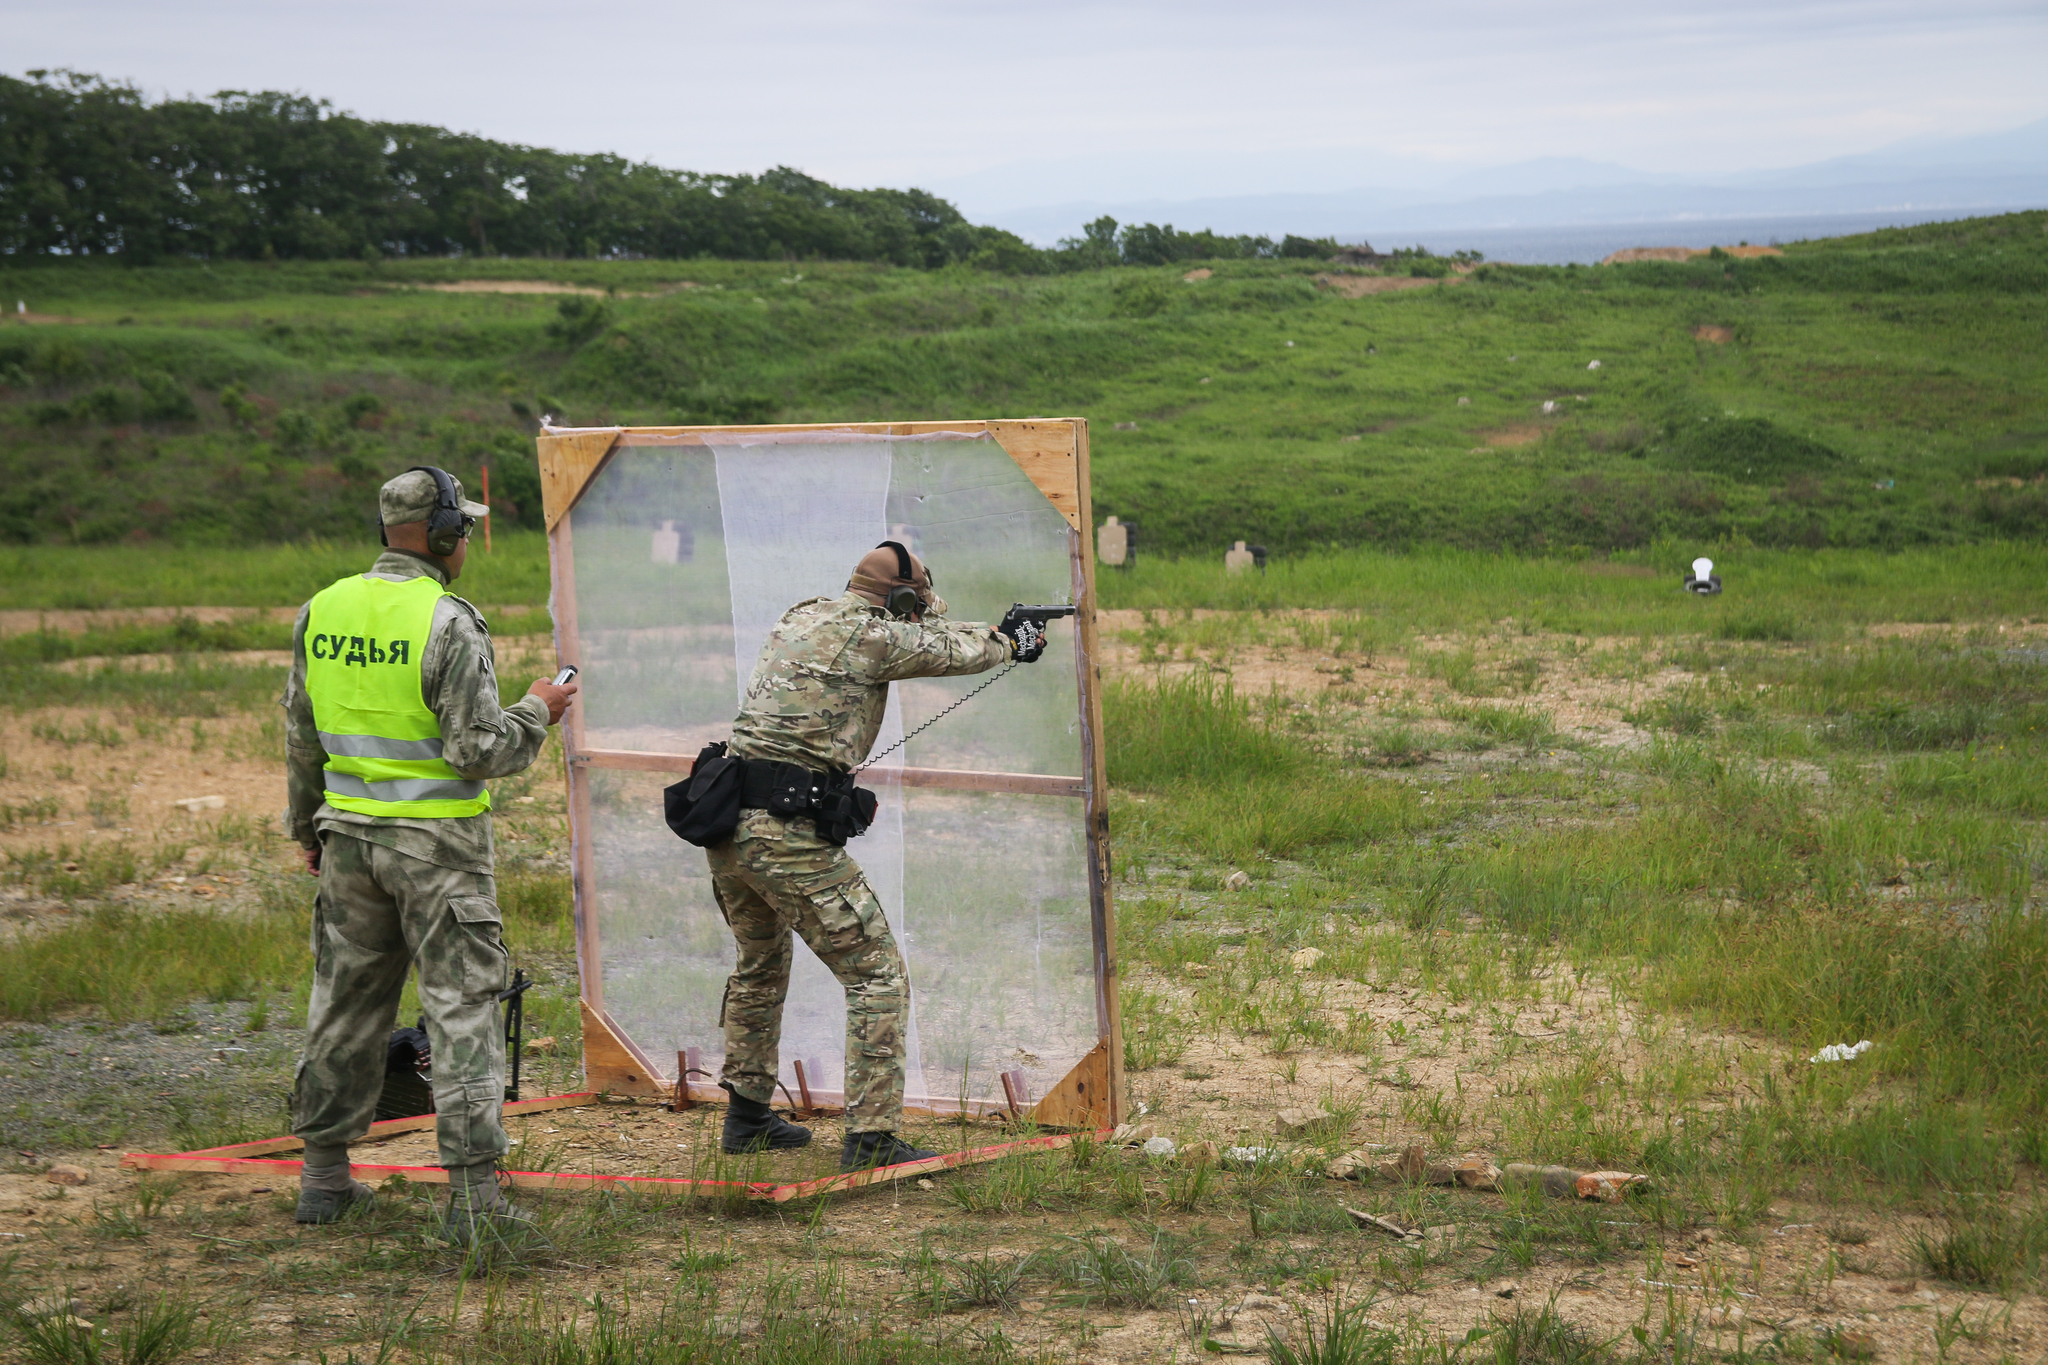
[733,591,1012,772]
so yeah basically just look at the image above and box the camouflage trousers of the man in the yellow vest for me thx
[291,831,510,1166]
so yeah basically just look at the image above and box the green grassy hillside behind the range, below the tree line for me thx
[0,213,2048,553]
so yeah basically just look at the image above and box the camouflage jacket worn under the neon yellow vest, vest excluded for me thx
[279,551,547,874]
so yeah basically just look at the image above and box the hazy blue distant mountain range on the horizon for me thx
[958,119,2048,244]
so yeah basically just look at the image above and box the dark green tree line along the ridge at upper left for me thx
[0,72,1335,272]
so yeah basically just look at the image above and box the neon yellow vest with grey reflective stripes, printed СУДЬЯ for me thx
[305,575,492,819]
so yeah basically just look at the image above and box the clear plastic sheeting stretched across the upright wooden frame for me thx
[557,434,1102,1111]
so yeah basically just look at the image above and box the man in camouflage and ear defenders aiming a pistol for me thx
[707,542,1036,1171]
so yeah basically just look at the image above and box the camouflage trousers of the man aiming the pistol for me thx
[705,810,909,1132]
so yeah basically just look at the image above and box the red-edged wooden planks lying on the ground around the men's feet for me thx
[121,1091,1110,1203]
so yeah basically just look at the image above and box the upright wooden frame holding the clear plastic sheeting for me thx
[539,417,1124,1130]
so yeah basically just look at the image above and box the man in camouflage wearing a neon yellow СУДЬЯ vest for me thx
[283,469,575,1242]
